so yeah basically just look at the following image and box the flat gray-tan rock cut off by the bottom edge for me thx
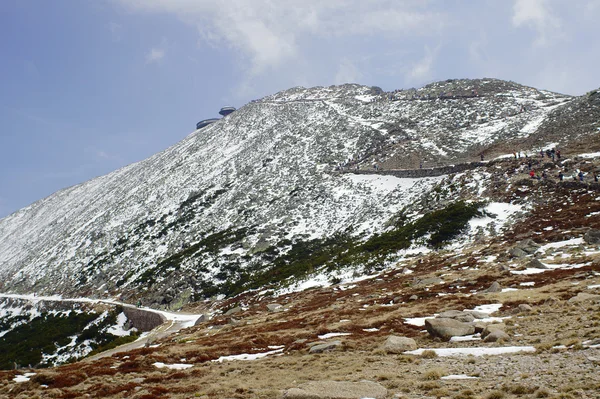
[283,381,387,399]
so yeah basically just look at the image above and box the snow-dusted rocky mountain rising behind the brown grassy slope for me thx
[0,79,600,308]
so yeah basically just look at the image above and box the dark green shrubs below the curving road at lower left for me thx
[0,309,135,370]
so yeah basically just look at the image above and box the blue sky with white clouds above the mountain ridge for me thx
[0,0,600,218]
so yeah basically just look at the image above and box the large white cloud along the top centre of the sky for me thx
[113,0,445,75]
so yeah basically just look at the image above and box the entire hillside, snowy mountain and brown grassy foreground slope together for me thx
[0,79,600,399]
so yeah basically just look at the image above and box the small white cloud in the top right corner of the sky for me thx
[512,0,561,46]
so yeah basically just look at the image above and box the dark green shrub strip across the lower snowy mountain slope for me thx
[198,201,482,297]
